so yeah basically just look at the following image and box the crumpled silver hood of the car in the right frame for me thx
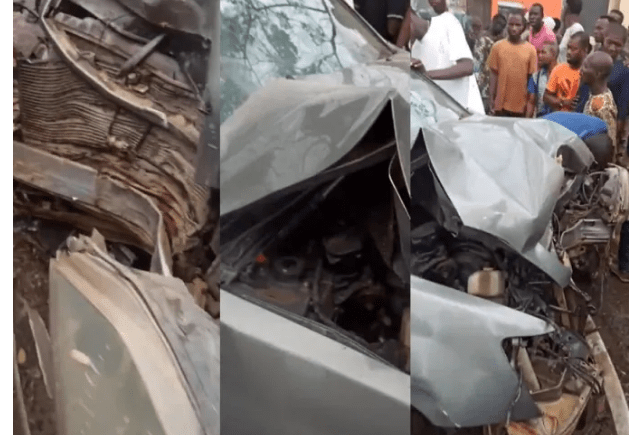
[421,115,596,286]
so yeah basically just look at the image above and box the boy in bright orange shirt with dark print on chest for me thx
[544,32,590,112]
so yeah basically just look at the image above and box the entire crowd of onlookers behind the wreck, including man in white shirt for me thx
[355,0,630,276]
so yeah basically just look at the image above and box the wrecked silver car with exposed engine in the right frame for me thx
[410,72,628,434]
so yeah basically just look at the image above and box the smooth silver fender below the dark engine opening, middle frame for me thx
[221,291,410,435]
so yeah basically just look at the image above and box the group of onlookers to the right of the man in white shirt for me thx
[466,0,630,151]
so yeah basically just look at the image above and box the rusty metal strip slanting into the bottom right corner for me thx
[586,316,630,435]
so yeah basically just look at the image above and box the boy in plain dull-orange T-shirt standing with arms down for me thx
[488,13,537,117]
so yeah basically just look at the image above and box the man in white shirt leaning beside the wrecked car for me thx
[411,0,485,114]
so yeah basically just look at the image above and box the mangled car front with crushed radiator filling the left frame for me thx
[13,0,220,435]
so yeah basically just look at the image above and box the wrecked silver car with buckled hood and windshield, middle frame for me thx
[220,0,410,434]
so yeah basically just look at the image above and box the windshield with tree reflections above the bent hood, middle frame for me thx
[220,0,392,122]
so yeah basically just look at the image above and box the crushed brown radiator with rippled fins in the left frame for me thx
[18,2,209,252]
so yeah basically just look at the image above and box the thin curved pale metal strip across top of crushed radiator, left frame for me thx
[41,0,198,146]
